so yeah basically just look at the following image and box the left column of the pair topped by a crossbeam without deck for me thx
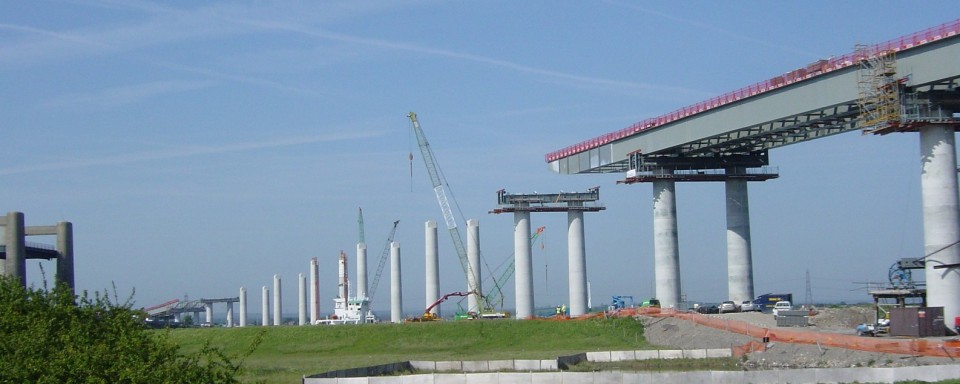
[513,203,534,319]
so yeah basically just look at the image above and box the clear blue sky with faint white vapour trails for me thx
[0,0,958,313]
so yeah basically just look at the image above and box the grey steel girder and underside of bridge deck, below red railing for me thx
[550,35,960,174]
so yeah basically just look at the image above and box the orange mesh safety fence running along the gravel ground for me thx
[636,308,960,358]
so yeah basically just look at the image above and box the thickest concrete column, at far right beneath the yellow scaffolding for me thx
[920,125,960,327]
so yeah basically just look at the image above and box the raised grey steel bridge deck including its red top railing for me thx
[546,20,960,174]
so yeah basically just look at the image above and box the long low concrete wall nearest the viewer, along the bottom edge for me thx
[303,365,960,384]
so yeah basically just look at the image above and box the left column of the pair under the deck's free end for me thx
[653,180,680,308]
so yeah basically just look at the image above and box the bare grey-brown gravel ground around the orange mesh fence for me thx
[640,307,960,369]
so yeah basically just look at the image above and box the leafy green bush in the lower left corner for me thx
[0,276,255,384]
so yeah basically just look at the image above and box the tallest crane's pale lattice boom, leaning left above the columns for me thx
[407,112,499,307]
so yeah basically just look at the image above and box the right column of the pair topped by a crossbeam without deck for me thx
[567,203,590,317]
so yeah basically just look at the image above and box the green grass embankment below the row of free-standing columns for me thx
[163,318,649,383]
